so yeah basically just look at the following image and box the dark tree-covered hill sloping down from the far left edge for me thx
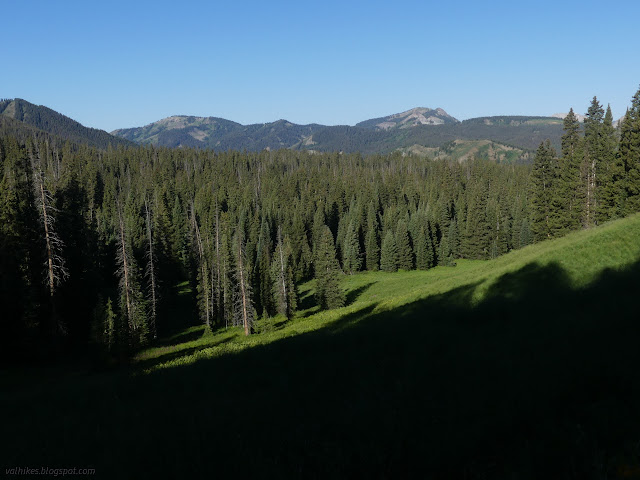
[0,98,133,149]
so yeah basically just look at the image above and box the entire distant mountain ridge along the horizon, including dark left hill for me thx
[0,99,563,163]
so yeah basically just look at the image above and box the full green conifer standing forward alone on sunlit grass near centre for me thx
[314,225,346,310]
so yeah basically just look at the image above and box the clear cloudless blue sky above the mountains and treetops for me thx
[0,0,640,131]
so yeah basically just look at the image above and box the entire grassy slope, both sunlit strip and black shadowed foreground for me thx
[0,215,640,478]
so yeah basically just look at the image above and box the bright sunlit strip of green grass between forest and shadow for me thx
[135,215,640,372]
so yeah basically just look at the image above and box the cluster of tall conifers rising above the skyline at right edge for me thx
[531,90,640,240]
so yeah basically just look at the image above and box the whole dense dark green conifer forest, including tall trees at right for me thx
[0,91,640,361]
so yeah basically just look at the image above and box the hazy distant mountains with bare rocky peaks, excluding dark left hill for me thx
[112,107,562,162]
